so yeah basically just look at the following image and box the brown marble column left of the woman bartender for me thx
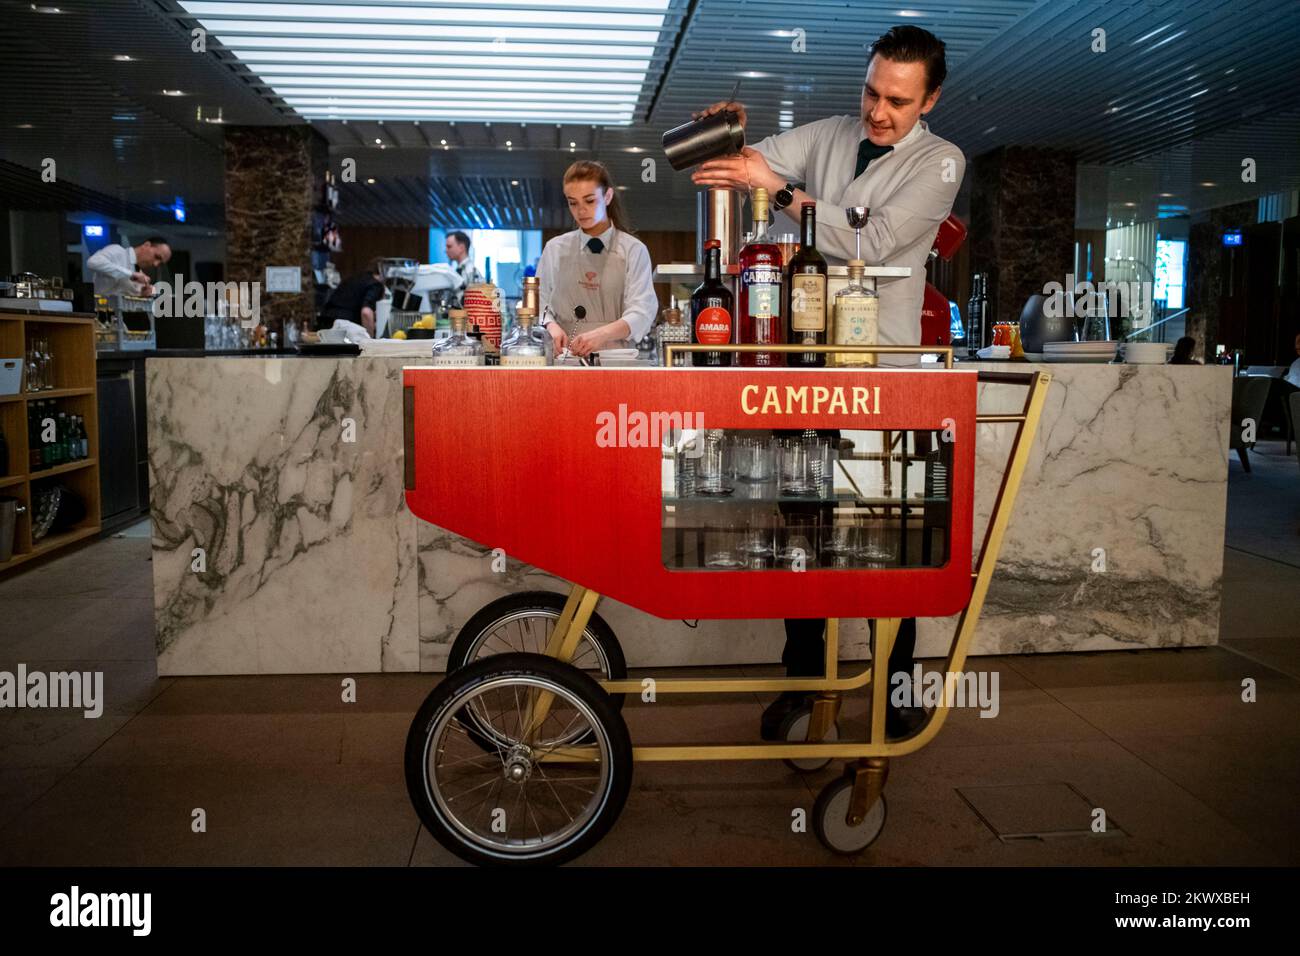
[226,126,329,336]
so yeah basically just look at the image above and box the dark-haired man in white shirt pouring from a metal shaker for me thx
[692,26,966,365]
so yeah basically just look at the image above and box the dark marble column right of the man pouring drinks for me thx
[970,147,1075,329]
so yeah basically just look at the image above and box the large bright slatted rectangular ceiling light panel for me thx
[177,0,676,126]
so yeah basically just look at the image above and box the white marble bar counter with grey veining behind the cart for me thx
[146,356,1231,675]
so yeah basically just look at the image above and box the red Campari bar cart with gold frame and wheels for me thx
[404,346,1049,865]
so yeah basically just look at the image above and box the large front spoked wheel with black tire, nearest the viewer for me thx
[406,654,632,865]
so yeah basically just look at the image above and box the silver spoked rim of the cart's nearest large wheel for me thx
[424,675,612,860]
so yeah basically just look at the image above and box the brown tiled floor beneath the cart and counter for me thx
[0,444,1300,866]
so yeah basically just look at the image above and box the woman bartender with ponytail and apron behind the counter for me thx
[537,160,659,355]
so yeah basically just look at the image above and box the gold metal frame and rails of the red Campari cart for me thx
[525,345,1052,825]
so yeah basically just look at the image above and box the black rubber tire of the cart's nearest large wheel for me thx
[406,654,632,866]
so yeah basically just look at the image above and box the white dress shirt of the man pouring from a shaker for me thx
[754,116,966,364]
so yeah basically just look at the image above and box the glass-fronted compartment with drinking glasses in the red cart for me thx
[660,429,953,571]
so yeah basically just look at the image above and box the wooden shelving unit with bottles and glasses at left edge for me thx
[0,310,100,574]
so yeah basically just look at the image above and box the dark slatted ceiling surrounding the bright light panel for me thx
[0,0,1300,229]
